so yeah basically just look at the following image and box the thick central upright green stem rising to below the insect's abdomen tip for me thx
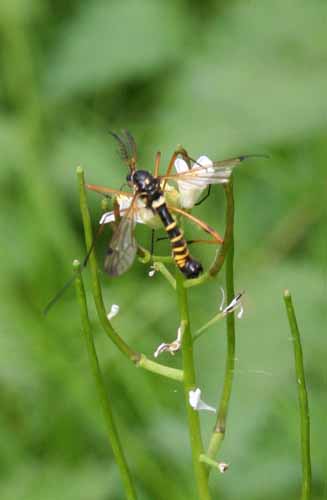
[176,269,211,500]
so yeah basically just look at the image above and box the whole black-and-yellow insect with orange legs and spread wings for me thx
[86,130,266,279]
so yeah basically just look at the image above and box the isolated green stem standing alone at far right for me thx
[284,290,311,500]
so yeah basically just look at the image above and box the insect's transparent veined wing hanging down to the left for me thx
[104,197,137,276]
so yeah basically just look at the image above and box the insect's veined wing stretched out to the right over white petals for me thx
[163,155,268,187]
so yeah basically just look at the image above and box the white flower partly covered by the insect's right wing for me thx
[175,156,222,208]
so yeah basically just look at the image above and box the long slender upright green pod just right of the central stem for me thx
[207,211,235,458]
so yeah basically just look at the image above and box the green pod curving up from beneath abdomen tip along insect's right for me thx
[184,177,234,288]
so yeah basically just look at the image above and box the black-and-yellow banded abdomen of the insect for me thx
[152,196,203,278]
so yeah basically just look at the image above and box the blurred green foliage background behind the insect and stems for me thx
[0,0,327,500]
